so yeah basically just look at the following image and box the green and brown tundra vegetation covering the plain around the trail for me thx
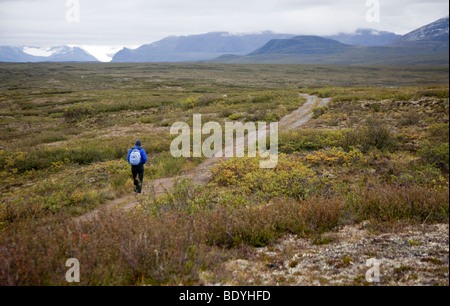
[0,64,449,285]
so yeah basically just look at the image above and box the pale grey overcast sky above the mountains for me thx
[0,0,449,60]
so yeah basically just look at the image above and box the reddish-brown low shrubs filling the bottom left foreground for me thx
[0,211,223,286]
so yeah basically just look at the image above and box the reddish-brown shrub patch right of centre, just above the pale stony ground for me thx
[204,198,345,248]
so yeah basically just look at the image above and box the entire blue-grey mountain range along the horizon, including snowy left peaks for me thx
[0,17,449,65]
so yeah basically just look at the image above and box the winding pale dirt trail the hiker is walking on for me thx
[76,94,331,222]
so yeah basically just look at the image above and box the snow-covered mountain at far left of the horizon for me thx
[0,46,98,63]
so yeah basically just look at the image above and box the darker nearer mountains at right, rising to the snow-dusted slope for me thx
[213,17,449,65]
